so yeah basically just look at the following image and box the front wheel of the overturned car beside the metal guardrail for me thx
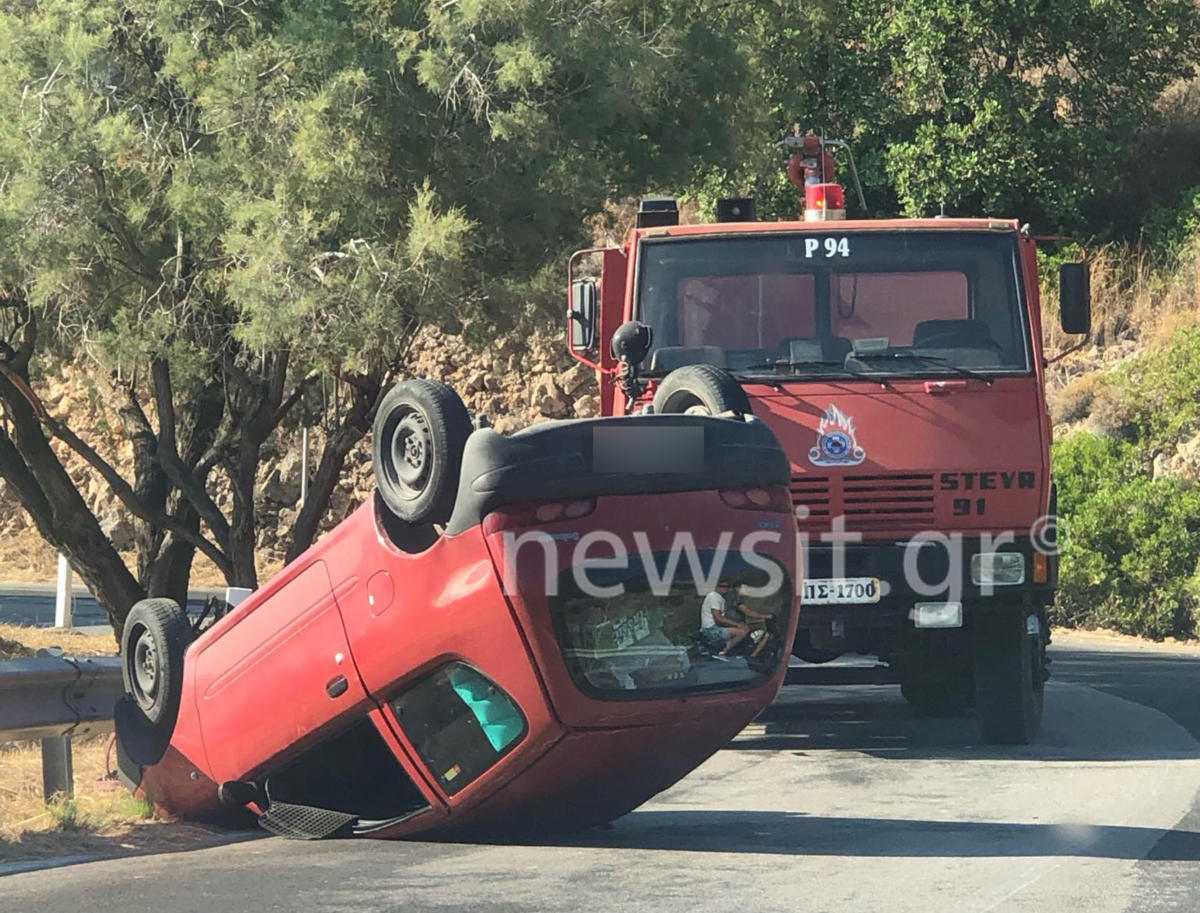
[121,599,192,733]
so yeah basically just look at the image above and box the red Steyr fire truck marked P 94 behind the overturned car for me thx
[568,136,1090,743]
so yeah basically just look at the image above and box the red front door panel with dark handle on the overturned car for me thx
[193,560,370,781]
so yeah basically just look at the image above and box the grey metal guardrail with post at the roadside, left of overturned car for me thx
[0,656,124,799]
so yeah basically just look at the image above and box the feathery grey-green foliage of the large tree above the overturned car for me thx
[0,0,745,373]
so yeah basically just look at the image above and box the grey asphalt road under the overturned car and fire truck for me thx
[0,638,1200,913]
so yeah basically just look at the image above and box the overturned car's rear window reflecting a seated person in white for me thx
[551,549,792,699]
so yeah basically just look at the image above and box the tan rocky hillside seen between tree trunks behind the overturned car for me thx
[0,330,599,585]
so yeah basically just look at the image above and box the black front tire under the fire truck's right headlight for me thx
[973,609,1045,745]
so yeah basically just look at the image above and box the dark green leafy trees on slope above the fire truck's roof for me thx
[698,0,1200,235]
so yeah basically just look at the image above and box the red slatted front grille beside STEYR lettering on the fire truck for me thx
[791,473,934,529]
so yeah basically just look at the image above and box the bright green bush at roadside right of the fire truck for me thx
[1052,433,1200,638]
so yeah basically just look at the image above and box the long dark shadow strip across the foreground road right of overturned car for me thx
[522,810,1200,863]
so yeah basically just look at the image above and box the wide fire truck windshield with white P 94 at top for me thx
[637,235,1030,377]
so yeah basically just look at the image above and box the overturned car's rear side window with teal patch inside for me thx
[391,662,527,795]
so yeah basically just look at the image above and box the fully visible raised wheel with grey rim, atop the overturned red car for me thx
[371,380,472,525]
